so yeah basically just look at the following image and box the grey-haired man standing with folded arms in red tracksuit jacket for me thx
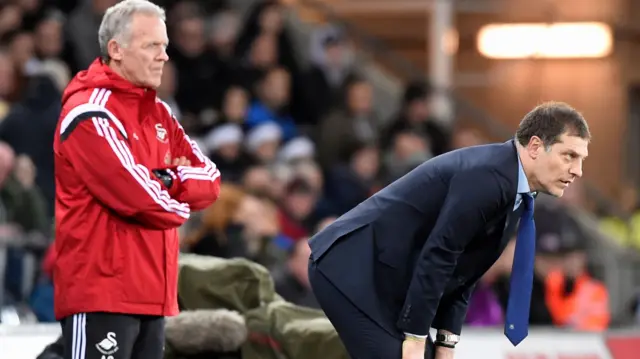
[53,0,220,359]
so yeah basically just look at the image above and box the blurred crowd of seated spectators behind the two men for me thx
[0,0,640,330]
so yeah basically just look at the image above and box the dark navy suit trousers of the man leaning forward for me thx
[309,260,435,359]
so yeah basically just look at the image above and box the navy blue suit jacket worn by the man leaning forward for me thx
[309,141,522,337]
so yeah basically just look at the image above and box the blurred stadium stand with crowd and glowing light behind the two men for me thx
[0,0,640,358]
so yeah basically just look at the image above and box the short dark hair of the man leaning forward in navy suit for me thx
[516,102,591,147]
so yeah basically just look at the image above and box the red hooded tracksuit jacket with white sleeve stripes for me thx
[53,60,220,319]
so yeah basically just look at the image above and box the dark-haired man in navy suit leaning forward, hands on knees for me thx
[309,102,590,359]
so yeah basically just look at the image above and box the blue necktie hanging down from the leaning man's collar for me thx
[504,194,536,346]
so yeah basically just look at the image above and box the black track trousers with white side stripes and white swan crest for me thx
[61,313,164,359]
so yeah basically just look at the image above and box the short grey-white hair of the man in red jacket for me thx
[98,0,166,61]
